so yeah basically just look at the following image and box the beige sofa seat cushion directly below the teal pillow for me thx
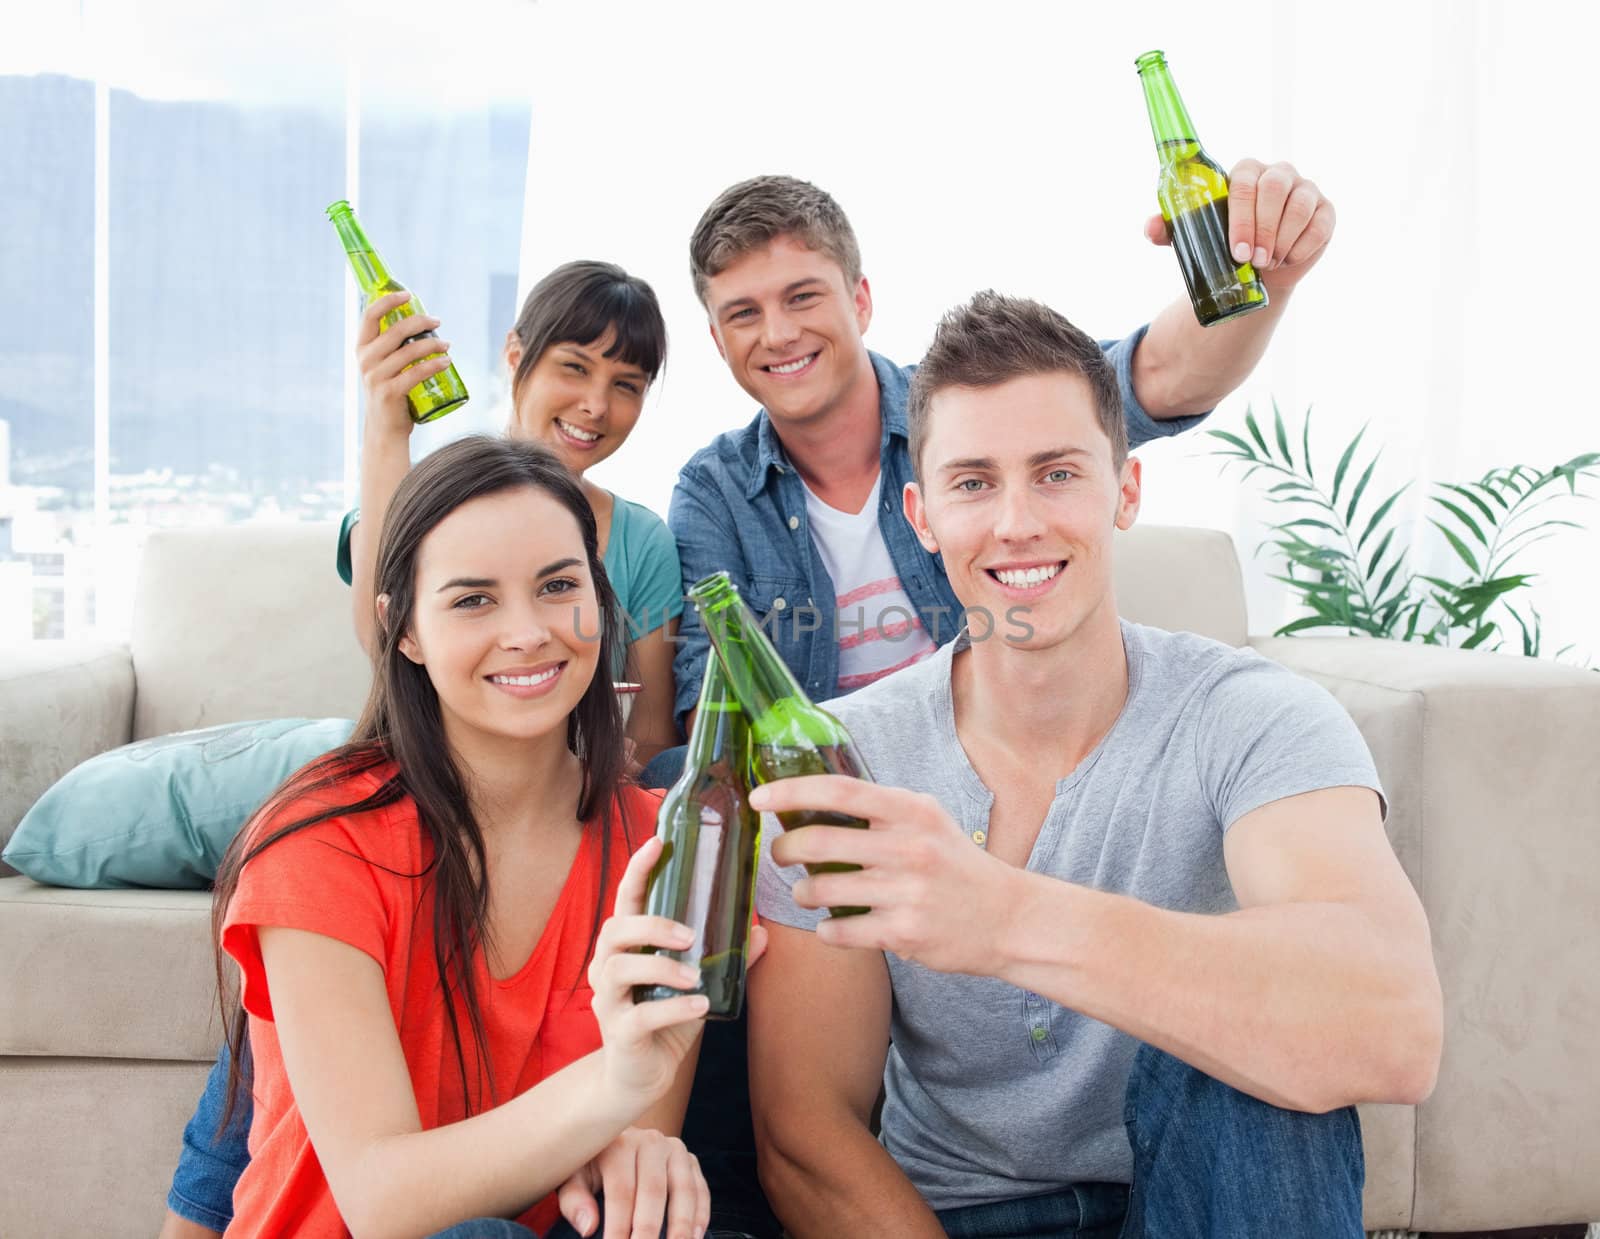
[0,877,222,1061]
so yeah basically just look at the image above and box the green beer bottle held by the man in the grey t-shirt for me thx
[690,571,872,916]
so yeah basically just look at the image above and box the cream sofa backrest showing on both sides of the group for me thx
[131,523,1245,740]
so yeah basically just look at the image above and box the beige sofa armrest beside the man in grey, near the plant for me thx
[1251,637,1600,1231]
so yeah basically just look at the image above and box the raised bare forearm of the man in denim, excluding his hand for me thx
[1133,288,1291,421]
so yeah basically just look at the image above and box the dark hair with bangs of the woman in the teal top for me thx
[510,259,667,391]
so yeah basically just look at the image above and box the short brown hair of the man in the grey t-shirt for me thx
[906,288,1128,482]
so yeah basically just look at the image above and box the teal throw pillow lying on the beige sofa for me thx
[5,719,355,890]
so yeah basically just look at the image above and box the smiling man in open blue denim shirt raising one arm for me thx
[669,172,1334,730]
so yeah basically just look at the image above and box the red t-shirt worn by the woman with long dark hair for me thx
[222,765,661,1239]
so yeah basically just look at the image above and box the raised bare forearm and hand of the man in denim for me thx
[1133,158,1334,421]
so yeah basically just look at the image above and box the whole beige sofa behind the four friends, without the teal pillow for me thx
[0,527,1600,1239]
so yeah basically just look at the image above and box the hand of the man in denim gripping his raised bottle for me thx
[1144,158,1336,293]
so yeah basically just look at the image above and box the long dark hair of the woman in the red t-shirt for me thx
[211,435,626,1132]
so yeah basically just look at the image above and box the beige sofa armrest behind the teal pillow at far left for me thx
[0,640,133,872]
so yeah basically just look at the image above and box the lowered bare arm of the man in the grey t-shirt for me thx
[749,920,944,1239]
